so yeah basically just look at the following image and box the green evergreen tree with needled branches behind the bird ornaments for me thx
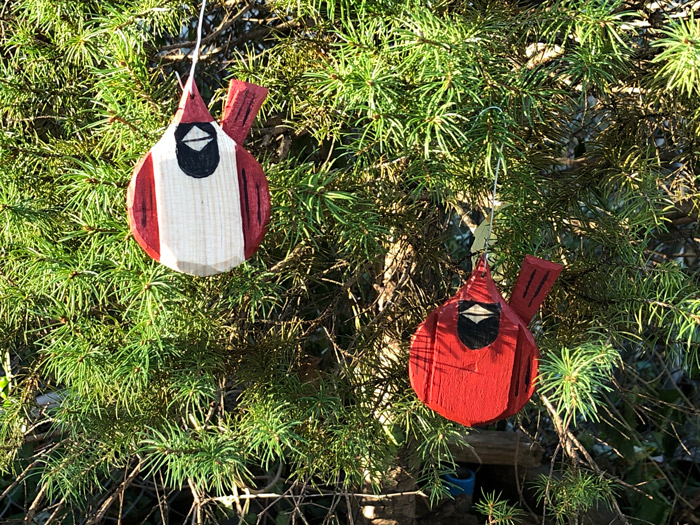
[0,0,700,523]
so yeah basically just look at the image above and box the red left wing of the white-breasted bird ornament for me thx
[126,152,160,261]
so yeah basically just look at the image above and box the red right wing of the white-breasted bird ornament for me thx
[236,146,270,259]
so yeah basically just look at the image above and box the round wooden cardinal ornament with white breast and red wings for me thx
[127,76,270,276]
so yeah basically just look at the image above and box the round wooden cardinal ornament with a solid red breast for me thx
[409,255,562,426]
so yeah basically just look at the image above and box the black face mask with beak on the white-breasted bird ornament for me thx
[175,122,219,179]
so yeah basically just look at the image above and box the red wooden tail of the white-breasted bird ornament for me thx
[221,80,267,145]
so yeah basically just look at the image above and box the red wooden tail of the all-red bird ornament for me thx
[509,255,562,325]
